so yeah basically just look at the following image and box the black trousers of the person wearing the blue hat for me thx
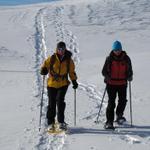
[106,84,127,123]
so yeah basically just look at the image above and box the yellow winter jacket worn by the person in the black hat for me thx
[41,50,77,88]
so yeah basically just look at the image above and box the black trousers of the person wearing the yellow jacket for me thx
[47,86,68,125]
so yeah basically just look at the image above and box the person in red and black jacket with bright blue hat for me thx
[102,41,133,129]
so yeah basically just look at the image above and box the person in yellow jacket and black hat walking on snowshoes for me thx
[41,41,78,128]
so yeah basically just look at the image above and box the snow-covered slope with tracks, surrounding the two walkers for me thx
[0,0,150,150]
